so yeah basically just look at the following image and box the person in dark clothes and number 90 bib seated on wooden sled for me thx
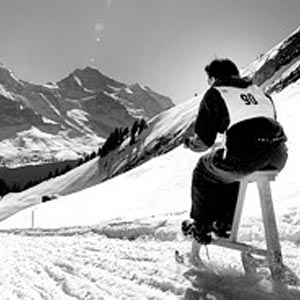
[182,59,287,244]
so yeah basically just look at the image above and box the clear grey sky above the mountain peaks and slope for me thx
[0,0,300,103]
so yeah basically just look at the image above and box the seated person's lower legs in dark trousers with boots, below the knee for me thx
[182,151,239,244]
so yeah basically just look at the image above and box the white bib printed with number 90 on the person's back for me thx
[214,85,275,129]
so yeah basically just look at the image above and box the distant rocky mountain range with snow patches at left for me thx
[0,66,174,166]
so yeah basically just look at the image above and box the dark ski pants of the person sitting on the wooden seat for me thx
[190,142,287,225]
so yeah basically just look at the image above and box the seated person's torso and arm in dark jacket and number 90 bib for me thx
[195,76,286,173]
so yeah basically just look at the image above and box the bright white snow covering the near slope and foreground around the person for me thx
[0,82,300,300]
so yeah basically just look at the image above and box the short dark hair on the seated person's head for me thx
[204,59,240,80]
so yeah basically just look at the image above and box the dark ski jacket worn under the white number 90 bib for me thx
[194,77,287,156]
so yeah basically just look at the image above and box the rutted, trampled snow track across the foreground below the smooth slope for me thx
[0,218,300,300]
